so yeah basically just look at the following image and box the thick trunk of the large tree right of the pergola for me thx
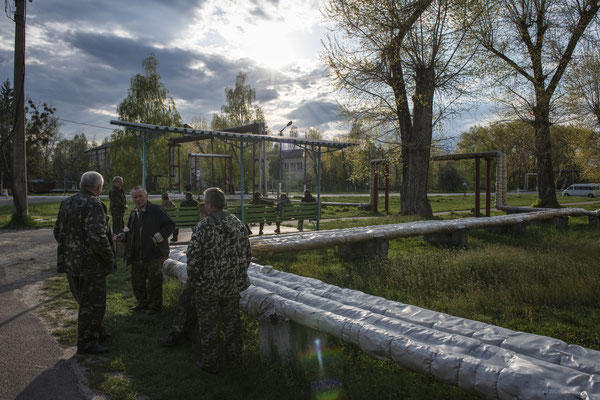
[400,67,435,218]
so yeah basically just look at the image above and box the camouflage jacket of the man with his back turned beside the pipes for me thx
[187,211,252,297]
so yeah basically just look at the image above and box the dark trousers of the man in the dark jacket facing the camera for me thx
[131,257,166,310]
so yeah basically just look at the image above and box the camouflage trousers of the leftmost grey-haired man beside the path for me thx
[67,274,106,349]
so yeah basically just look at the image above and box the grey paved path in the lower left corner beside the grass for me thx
[0,229,98,400]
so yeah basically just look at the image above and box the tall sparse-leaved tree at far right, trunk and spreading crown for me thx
[470,0,600,207]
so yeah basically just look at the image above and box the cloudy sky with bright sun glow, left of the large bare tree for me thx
[0,0,486,142]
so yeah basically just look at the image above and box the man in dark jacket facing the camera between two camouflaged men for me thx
[117,186,175,314]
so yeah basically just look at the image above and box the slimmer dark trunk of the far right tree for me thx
[534,100,560,208]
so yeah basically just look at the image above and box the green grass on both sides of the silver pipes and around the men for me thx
[34,208,600,399]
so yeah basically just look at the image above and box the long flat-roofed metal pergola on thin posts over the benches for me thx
[110,120,357,230]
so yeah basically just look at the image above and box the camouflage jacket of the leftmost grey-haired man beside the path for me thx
[54,189,116,276]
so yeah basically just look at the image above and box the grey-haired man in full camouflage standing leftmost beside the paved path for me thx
[54,171,116,354]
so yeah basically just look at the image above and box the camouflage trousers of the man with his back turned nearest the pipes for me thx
[195,288,242,369]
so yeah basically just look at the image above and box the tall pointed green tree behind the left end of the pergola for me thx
[109,54,182,191]
